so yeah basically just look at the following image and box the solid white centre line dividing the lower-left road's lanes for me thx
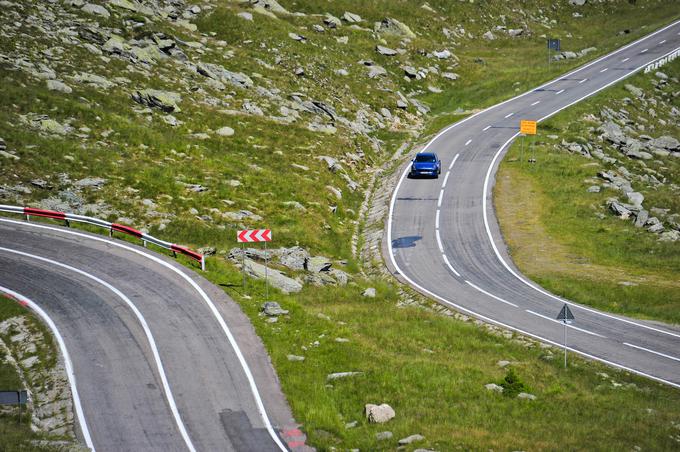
[0,247,196,452]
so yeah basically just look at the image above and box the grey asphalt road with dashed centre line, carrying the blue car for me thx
[385,22,680,387]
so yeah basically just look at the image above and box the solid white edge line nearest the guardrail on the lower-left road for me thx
[0,218,286,451]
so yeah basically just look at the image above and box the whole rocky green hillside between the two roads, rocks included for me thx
[0,0,680,450]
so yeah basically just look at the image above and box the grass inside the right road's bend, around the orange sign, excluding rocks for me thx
[495,57,680,324]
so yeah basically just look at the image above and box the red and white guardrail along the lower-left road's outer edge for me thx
[0,204,205,271]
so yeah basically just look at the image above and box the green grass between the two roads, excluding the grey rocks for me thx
[0,1,680,450]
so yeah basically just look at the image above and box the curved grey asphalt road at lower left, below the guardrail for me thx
[0,218,299,451]
